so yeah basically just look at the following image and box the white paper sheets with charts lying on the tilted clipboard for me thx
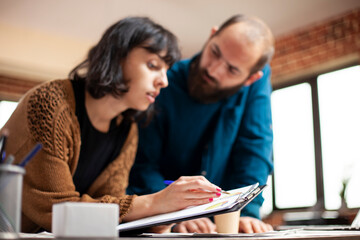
[117,184,259,232]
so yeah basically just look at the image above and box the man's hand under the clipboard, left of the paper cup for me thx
[173,218,216,233]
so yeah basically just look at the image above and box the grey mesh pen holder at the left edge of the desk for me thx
[0,164,25,239]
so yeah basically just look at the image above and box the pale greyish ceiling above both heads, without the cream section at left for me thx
[0,0,360,56]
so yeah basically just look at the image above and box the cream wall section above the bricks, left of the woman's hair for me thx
[0,24,94,81]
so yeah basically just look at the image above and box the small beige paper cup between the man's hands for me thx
[214,210,240,233]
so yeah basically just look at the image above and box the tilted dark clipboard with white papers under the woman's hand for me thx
[116,183,266,232]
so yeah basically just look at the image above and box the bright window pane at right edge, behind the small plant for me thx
[318,66,360,209]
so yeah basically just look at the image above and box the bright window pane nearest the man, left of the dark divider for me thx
[271,83,316,208]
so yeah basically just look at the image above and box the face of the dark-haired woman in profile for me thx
[121,47,168,111]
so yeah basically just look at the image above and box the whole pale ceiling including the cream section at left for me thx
[0,0,360,81]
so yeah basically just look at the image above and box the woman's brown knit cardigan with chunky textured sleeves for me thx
[3,80,138,232]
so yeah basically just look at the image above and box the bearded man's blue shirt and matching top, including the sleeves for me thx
[128,56,273,218]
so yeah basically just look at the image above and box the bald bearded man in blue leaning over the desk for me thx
[128,15,274,233]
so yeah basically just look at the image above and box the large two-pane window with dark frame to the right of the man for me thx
[271,66,360,210]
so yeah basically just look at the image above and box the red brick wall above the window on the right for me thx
[271,8,360,86]
